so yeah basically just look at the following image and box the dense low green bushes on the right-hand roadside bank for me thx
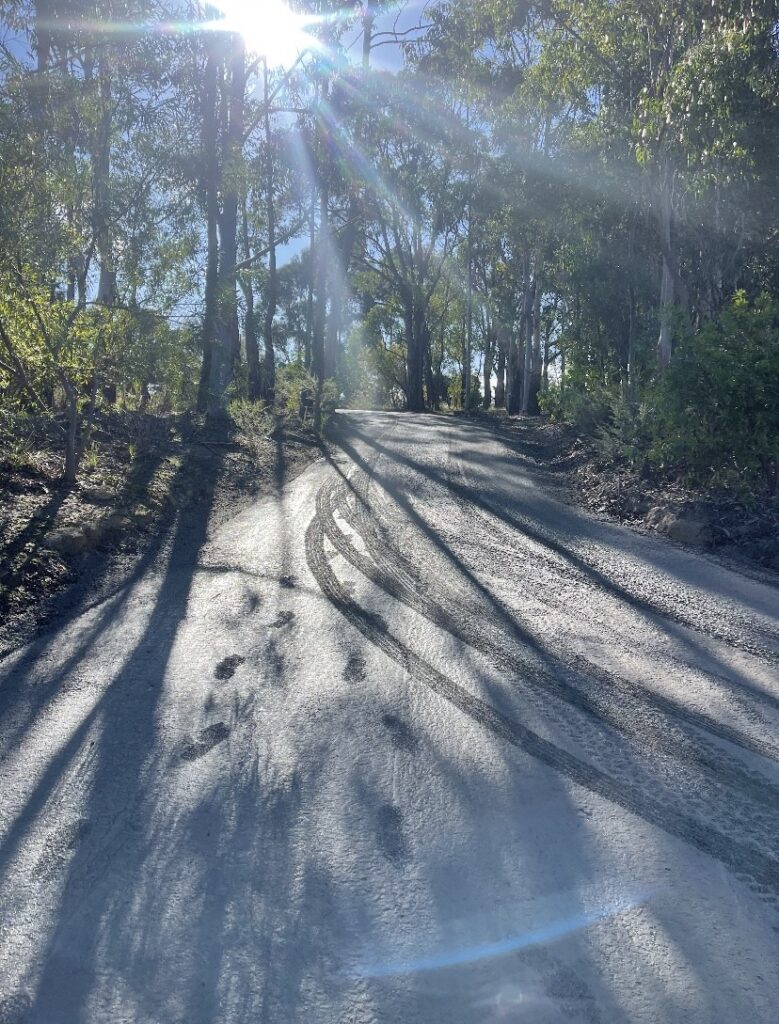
[539,292,779,493]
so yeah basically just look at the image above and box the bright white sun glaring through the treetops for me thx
[209,0,318,68]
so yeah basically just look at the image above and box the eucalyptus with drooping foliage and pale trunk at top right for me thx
[515,0,777,368]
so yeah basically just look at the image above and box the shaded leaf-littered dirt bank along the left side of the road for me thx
[0,413,321,657]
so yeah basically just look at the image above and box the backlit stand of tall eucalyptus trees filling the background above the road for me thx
[0,0,779,488]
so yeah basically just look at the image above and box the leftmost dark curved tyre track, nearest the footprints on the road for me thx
[305,483,779,896]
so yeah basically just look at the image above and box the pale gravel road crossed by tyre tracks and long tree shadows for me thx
[0,413,779,1024]
